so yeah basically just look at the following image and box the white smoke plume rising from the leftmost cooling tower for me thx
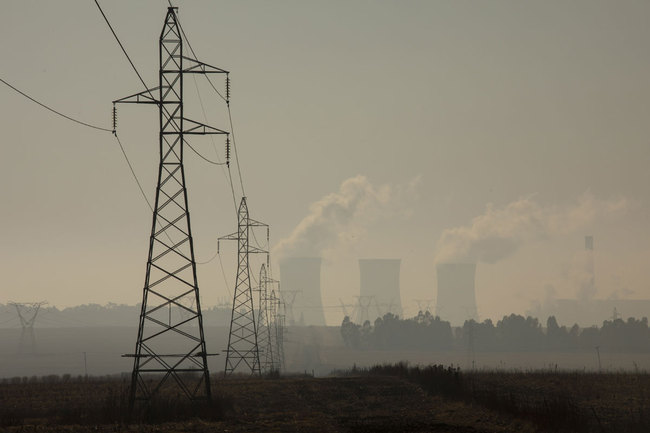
[274,175,419,258]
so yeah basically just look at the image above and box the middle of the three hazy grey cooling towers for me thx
[358,259,402,323]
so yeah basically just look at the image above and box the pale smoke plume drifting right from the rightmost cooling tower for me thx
[436,193,628,263]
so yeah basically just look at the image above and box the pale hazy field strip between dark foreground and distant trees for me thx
[5,326,650,379]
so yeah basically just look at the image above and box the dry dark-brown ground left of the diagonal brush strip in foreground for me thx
[0,370,534,433]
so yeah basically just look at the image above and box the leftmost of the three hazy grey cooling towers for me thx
[280,257,325,326]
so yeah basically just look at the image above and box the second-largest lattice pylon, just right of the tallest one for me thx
[217,197,269,375]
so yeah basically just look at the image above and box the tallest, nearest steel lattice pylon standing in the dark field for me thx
[114,7,227,407]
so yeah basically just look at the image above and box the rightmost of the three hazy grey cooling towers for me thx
[436,263,478,326]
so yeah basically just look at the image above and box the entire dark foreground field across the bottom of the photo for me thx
[0,364,650,433]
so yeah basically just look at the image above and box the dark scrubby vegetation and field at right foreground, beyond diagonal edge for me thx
[339,363,650,433]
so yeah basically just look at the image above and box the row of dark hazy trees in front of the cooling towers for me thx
[341,312,650,352]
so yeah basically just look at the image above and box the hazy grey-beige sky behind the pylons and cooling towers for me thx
[0,0,650,324]
